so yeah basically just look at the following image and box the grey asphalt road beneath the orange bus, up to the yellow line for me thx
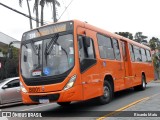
[1,82,160,120]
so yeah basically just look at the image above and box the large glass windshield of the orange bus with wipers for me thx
[21,34,74,78]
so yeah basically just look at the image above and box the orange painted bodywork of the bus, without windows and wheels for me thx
[20,20,154,104]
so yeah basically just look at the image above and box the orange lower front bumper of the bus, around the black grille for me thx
[21,85,83,104]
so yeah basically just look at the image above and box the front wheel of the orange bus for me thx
[98,81,113,105]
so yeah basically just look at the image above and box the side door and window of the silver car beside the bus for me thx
[2,79,22,103]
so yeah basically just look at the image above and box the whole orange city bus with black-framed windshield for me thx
[19,20,154,105]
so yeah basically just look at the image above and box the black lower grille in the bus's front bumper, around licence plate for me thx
[29,93,60,102]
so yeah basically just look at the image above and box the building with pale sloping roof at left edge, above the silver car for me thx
[0,32,20,80]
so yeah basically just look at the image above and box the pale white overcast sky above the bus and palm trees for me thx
[0,0,160,40]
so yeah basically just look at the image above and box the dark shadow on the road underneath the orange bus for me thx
[41,87,151,117]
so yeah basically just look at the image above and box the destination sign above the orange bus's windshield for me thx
[22,22,73,40]
